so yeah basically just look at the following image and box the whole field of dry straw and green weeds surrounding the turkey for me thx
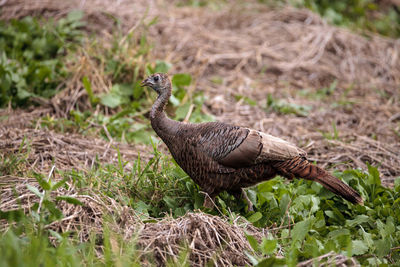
[0,0,400,266]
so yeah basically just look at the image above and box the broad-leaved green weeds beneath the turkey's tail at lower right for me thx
[241,166,400,266]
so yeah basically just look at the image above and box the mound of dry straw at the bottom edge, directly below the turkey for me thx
[138,213,263,266]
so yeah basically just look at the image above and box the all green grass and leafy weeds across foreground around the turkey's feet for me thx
[0,149,400,266]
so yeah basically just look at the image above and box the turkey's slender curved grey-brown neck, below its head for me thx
[150,85,182,144]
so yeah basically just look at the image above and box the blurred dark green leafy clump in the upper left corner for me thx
[0,11,83,107]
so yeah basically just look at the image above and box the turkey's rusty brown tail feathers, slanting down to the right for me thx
[277,157,364,204]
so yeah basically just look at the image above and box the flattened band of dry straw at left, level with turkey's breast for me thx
[0,125,149,172]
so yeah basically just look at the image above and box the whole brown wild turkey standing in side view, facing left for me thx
[142,73,363,208]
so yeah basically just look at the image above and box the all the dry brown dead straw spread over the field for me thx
[0,0,400,266]
